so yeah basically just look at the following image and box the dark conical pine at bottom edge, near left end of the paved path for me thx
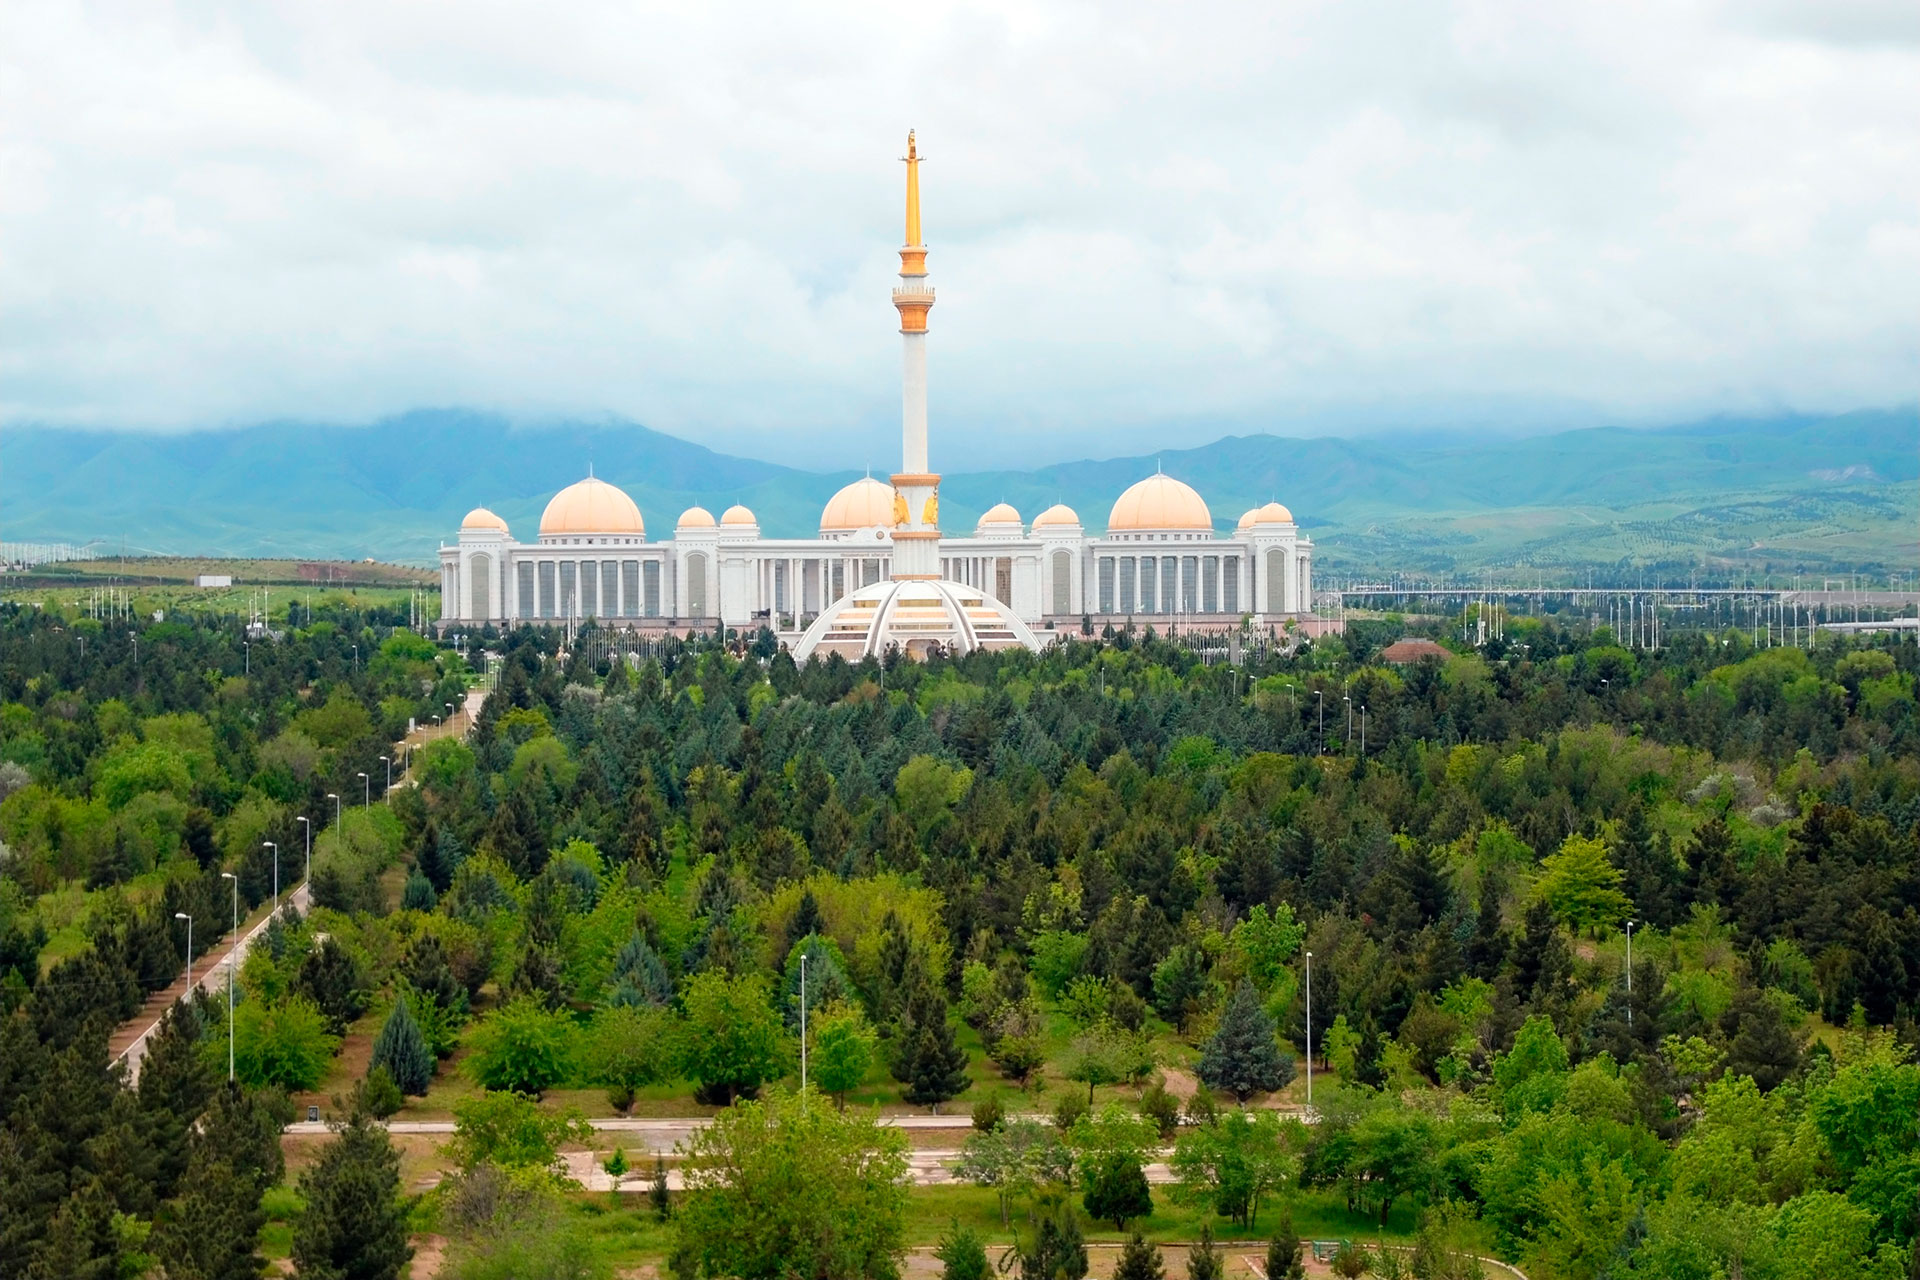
[294,1115,413,1280]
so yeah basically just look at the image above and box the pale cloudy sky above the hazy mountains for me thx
[0,0,1920,470]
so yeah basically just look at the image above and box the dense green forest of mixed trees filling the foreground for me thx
[0,601,1920,1280]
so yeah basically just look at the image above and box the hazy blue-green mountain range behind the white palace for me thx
[0,409,1920,572]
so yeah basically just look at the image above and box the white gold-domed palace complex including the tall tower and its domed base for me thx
[440,134,1313,662]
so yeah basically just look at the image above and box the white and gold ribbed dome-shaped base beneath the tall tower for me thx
[793,580,1041,662]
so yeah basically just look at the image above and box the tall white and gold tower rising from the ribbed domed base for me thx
[893,130,941,578]
